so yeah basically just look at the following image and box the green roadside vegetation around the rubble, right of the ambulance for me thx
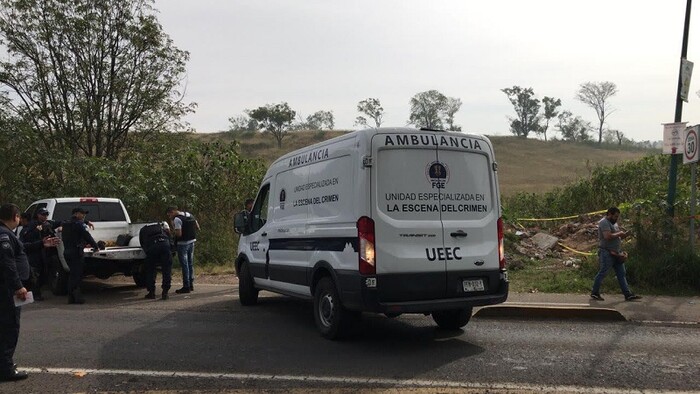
[503,154,700,294]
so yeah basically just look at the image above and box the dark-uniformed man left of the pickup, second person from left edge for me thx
[19,208,58,301]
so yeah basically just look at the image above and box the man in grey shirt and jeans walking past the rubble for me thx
[591,207,642,301]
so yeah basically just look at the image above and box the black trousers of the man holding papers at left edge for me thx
[0,283,22,375]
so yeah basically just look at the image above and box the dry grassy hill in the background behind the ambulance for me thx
[194,131,658,196]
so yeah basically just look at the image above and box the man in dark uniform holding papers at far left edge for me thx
[0,204,29,382]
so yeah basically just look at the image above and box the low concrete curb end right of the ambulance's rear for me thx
[473,306,627,321]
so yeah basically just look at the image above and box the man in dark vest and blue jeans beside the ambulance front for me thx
[165,206,199,294]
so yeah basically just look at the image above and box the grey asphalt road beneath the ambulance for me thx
[6,282,700,393]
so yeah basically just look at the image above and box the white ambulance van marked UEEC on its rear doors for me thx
[234,128,508,339]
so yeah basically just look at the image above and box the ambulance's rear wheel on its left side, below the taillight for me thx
[314,277,360,339]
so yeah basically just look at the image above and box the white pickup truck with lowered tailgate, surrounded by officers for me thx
[26,197,161,295]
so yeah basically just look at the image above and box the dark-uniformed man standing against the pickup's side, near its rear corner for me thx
[61,207,97,304]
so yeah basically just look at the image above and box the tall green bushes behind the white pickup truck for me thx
[0,133,266,264]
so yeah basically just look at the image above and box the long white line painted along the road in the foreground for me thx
[20,367,697,394]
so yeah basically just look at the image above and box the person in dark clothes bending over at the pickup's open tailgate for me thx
[139,223,173,300]
